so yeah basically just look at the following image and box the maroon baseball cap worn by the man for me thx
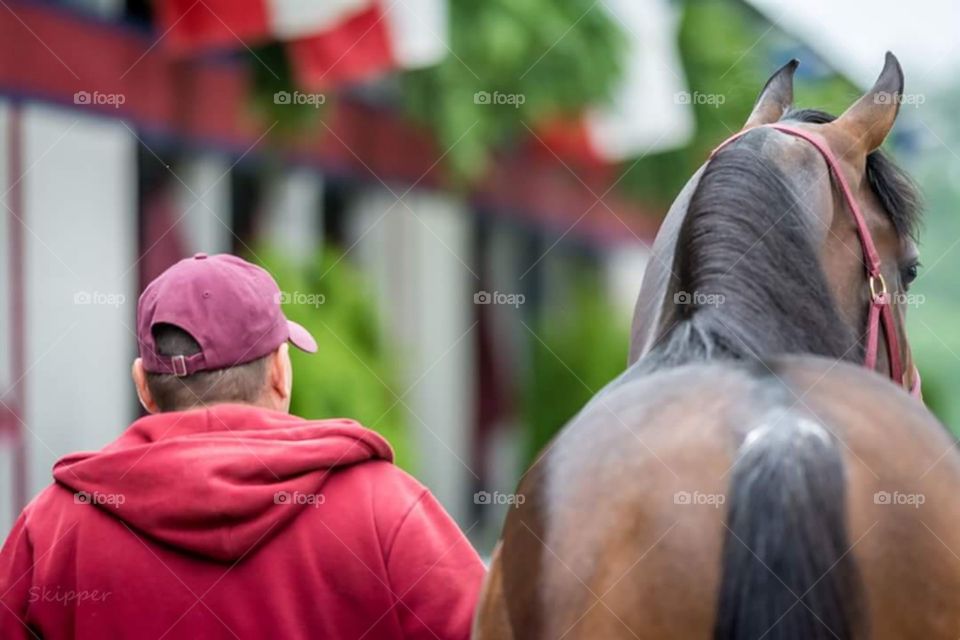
[137,253,317,376]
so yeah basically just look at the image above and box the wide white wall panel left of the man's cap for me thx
[22,105,137,496]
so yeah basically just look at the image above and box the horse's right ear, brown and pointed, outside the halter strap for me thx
[827,51,903,155]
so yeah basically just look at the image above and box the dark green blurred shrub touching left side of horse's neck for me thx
[521,279,630,468]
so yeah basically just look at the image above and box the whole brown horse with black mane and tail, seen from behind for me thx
[474,54,960,640]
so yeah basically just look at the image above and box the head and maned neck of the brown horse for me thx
[631,54,919,386]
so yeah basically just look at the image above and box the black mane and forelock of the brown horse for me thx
[642,109,920,371]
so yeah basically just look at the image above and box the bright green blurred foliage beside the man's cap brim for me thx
[251,248,415,469]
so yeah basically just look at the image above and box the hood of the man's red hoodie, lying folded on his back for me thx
[53,404,393,561]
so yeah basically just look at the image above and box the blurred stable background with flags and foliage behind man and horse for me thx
[0,0,960,551]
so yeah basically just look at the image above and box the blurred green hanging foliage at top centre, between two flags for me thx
[401,0,626,178]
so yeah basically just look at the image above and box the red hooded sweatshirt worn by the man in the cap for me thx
[0,405,484,640]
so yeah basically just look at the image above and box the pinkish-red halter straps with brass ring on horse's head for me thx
[710,123,920,397]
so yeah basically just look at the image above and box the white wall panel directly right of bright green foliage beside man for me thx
[350,187,479,527]
